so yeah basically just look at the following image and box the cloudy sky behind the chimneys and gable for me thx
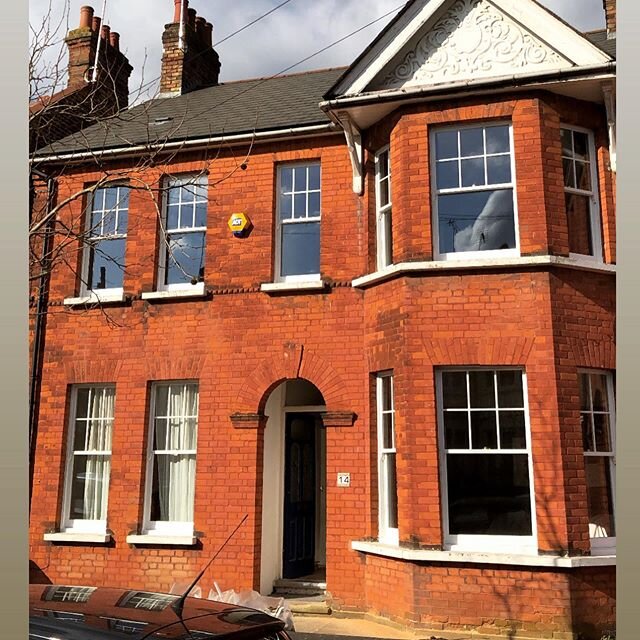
[29,0,604,100]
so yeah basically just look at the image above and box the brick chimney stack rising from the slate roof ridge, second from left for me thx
[160,0,220,97]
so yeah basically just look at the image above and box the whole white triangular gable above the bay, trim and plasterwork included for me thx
[326,0,612,98]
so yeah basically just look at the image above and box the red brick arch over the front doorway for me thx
[234,343,349,415]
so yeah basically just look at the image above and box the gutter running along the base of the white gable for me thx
[320,60,616,112]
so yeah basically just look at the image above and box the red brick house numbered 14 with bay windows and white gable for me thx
[30,0,616,639]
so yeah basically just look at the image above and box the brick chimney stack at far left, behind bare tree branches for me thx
[65,6,133,106]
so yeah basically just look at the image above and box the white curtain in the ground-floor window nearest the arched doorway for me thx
[156,384,198,522]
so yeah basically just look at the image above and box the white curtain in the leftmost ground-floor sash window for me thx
[83,388,115,520]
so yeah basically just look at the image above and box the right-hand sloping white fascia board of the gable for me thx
[492,0,612,66]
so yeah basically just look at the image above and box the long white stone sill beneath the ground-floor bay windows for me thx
[351,540,616,569]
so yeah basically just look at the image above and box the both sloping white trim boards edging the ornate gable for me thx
[332,0,612,96]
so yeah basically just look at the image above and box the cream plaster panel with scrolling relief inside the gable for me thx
[372,0,571,89]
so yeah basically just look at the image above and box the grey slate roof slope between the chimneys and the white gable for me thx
[38,68,344,156]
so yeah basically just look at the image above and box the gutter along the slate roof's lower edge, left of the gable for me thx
[30,122,338,164]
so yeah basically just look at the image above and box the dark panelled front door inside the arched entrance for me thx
[282,413,316,578]
